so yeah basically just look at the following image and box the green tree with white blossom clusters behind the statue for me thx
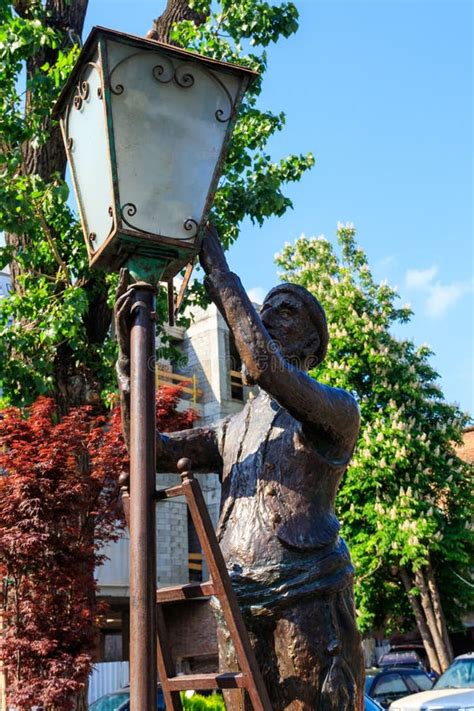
[276,226,473,670]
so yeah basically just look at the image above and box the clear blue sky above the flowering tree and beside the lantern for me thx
[85,0,474,413]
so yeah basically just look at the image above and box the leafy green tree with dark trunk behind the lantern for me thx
[0,0,313,411]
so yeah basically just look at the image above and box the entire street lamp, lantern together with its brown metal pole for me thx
[53,27,256,711]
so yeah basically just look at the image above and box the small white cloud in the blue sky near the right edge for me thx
[405,265,474,319]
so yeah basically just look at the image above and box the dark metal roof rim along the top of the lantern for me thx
[52,26,259,119]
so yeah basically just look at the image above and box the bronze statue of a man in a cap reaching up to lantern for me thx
[116,228,364,711]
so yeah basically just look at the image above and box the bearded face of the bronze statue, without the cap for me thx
[260,291,320,370]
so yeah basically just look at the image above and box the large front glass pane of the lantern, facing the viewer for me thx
[107,41,240,240]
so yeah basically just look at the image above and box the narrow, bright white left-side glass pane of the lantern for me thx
[65,58,113,251]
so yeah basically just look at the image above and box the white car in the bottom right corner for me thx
[389,652,474,711]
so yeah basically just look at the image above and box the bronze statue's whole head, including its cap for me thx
[260,283,329,370]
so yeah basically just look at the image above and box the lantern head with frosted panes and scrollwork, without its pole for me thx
[54,27,256,281]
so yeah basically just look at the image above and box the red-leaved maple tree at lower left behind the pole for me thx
[0,386,197,710]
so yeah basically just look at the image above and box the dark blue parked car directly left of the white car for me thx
[365,667,433,708]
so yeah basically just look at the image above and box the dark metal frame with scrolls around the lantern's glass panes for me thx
[53,27,258,280]
